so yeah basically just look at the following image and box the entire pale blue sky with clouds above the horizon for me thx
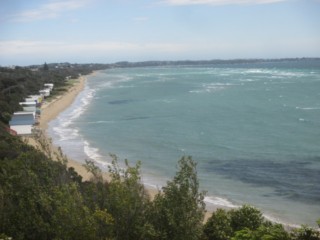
[0,0,320,66]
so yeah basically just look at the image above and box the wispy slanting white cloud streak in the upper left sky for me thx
[11,0,90,22]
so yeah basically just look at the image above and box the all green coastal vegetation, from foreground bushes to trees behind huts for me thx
[0,64,320,240]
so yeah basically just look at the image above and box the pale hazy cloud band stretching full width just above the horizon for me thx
[0,39,320,65]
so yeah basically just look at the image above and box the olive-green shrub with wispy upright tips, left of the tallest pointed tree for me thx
[105,155,150,240]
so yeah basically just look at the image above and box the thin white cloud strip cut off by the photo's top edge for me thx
[162,0,287,6]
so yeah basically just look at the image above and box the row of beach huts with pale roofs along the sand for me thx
[9,83,54,136]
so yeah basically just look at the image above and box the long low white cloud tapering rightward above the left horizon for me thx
[0,40,190,65]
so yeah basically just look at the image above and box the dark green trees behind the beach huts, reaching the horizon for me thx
[0,63,109,124]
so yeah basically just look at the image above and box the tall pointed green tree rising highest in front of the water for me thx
[151,156,205,240]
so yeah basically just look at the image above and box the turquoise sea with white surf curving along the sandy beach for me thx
[48,59,320,226]
